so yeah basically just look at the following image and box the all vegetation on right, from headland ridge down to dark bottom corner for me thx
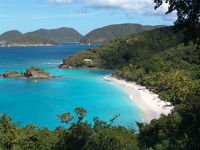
[58,27,200,150]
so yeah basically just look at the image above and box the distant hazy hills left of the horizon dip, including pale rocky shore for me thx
[0,28,82,47]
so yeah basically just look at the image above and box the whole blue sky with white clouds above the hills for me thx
[0,0,175,35]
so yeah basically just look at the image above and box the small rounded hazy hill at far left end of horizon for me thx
[0,30,23,41]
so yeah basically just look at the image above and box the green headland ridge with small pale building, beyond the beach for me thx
[60,27,182,69]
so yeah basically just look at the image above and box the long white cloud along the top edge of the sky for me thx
[48,0,172,15]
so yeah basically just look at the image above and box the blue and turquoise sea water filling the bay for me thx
[0,44,141,129]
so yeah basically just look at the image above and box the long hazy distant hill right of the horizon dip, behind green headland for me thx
[80,24,163,44]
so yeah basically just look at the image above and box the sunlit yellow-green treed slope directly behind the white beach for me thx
[113,45,200,104]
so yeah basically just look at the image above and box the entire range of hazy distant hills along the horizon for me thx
[0,23,163,47]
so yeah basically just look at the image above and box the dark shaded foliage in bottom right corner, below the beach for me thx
[139,104,200,150]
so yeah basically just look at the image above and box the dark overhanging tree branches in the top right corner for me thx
[154,0,200,46]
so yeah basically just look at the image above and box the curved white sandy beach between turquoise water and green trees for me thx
[104,76,173,122]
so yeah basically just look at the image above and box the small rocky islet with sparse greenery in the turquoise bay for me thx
[0,67,61,79]
